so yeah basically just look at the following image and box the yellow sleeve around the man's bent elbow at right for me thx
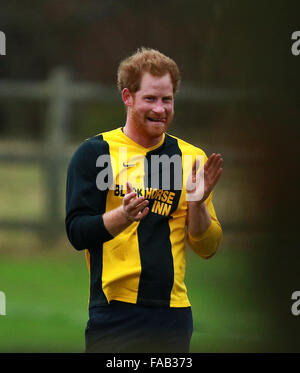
[187,193,223,259]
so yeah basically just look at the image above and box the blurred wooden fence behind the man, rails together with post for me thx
[0,68,261,238]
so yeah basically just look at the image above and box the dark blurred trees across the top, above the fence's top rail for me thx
[0,0,299,138]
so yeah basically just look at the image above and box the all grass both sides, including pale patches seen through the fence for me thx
[0,149,276,352]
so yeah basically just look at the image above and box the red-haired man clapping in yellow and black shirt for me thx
[66,48,222,352]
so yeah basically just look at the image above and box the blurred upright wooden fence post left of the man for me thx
[44,68,71,239]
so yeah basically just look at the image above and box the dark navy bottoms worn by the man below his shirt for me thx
[85,301,193,353]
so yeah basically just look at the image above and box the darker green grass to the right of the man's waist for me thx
[186,249,273,352]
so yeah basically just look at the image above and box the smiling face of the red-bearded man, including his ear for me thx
[123,72,174,146]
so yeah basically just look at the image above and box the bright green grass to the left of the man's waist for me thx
[0,248,88,352]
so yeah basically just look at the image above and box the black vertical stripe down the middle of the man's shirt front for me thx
[137,135,182,306]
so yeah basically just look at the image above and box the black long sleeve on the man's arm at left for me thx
[65,138,113,250]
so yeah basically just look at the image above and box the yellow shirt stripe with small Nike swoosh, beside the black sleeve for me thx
[102,130,143,303]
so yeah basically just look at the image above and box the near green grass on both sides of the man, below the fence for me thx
[0,232,271,352]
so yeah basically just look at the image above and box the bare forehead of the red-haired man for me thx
[140,72,173,95]
